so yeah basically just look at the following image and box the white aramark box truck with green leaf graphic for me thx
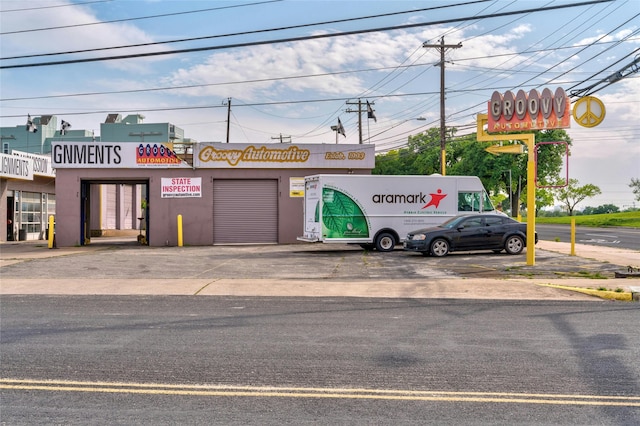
[297,174,495,252]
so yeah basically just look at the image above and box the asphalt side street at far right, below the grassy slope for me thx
[536,223,640,250]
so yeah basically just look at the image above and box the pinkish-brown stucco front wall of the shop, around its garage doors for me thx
[55,168,370,247]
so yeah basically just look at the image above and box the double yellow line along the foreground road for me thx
[0,379,640,407]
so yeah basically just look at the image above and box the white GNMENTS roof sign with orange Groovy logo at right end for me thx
[51,141,190,169]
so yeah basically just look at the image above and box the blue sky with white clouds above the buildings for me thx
[0,0,640,208]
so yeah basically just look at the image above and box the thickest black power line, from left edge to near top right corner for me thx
[0,0,614,69]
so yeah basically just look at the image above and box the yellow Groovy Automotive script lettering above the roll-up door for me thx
[198,146,310,166]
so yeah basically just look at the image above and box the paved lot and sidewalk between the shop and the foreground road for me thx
[0,239,640,300]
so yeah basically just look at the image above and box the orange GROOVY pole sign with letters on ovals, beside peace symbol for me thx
[487,88,571,132]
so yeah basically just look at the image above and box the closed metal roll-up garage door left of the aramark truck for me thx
[213,179,278,244]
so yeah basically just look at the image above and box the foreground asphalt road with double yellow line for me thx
[0,296,640,425]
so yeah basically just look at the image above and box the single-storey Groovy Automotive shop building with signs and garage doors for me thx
[51,141,375,247]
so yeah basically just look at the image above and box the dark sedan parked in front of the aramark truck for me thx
[404,214,538,257]
